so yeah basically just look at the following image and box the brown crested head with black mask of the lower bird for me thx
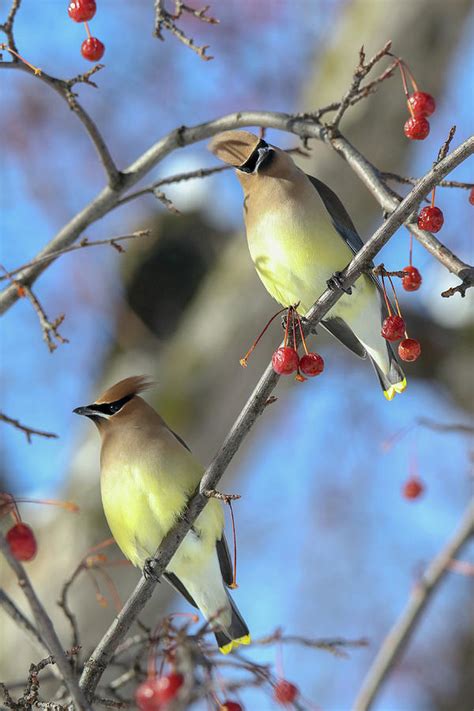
[73,375,151,430]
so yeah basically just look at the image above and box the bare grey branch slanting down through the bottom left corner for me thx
[0,535,92,711]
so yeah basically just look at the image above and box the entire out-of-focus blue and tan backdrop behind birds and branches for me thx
[0,0,474,711]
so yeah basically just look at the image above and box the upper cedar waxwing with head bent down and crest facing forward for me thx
[209,131,406,400]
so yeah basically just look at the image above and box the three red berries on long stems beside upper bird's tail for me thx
[381,272,421,362]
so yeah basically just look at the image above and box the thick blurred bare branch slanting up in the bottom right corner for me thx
[354,501,474,711]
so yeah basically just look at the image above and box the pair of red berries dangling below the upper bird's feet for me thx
[240,305,324,382]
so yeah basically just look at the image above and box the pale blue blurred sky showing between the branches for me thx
[0,1,474,711]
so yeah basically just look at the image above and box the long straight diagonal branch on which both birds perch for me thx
[80,139,474,698]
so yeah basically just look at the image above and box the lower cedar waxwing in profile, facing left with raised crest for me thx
[74,376,250,654]
